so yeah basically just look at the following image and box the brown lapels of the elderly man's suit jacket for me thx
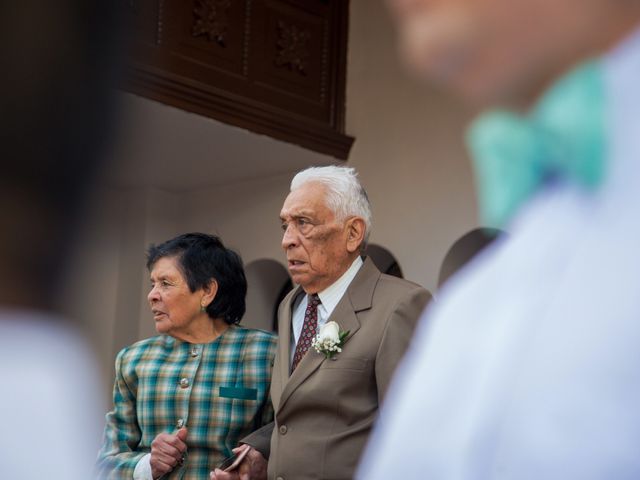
[274,259,380,412]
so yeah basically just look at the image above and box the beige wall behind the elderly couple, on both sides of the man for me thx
[69,0,476,398]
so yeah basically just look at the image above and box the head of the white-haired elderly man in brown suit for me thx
[280,166,371,293]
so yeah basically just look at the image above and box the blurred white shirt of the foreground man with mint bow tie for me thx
[358,25,640,480]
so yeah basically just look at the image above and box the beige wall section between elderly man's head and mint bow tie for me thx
[347,0,477,292]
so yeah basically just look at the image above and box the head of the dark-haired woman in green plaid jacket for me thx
[147,233,247,334]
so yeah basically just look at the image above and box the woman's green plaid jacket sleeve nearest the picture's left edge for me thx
[97,349,148,479]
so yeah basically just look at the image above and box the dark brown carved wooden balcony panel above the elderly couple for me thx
[125,0,353,159]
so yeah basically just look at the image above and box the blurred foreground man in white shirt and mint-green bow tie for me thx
[359,0,640,480]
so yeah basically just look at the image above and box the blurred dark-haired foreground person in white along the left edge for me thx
[0,0,119,480]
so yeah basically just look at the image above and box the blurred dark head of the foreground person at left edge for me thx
[0,0,120,310]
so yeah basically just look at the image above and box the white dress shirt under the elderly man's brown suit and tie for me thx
[289,256,364,365]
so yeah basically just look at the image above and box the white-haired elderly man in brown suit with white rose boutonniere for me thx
[213,166,431,480]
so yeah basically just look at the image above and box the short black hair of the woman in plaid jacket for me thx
[147,233,247,324]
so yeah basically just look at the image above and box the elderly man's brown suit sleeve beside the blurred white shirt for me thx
[375,287,431,404]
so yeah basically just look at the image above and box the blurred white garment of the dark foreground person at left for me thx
[0,309,104,480]
